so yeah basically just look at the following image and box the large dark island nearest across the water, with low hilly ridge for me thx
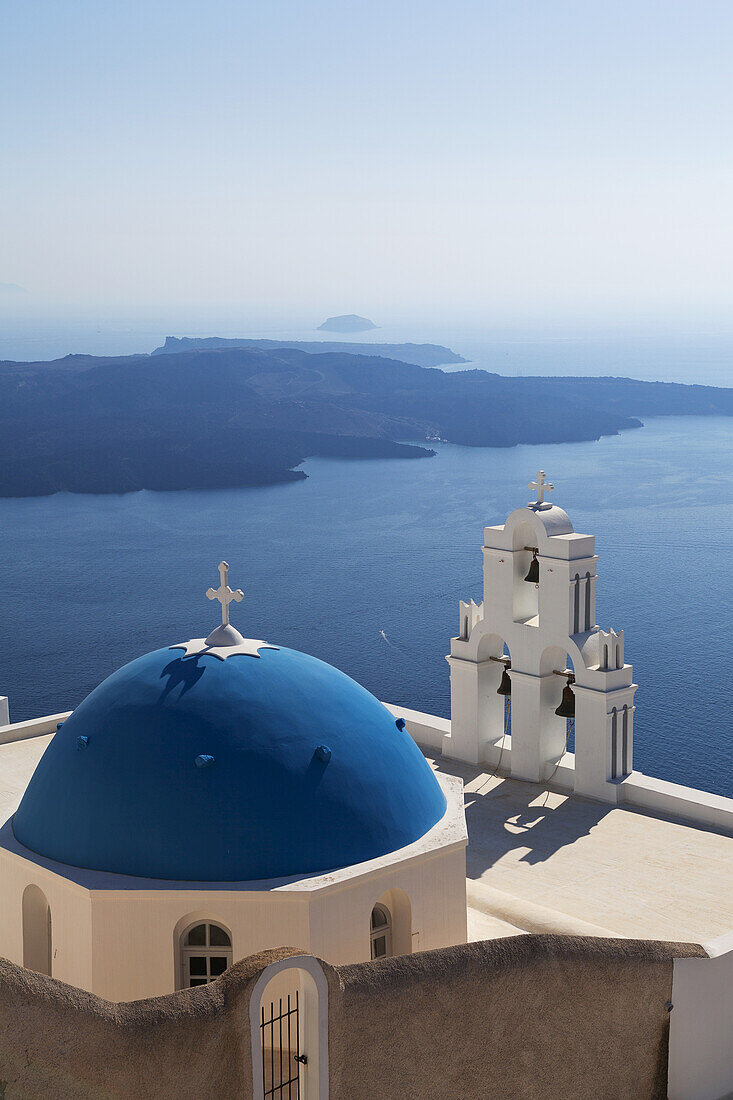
[0,347,733,496]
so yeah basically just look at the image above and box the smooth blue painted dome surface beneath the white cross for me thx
[13,648,446,882]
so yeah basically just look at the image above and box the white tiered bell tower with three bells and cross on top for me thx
[444,470,636,802]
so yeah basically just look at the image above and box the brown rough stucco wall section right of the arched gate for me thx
[329,936,704,1100]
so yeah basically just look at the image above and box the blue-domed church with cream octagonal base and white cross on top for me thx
[0,562,467,1001]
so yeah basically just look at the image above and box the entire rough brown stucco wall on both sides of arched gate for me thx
[0,936,704,1100]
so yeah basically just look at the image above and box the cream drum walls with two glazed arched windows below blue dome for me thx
[81,827,467,1001]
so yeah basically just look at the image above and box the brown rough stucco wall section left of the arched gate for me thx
[0,949,299,1100]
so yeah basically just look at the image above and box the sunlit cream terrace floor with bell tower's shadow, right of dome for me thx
[424,750,733,943]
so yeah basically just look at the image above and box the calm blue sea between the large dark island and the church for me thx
[0,418,733,795]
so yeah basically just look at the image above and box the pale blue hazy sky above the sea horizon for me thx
[0,0,733,322]
